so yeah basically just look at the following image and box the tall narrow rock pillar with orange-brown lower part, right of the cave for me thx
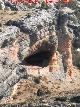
[57,8,73,76]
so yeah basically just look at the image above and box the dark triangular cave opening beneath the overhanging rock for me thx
[23,51,51,67]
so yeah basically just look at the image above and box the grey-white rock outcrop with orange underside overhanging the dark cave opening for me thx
[6,10,58,59]
